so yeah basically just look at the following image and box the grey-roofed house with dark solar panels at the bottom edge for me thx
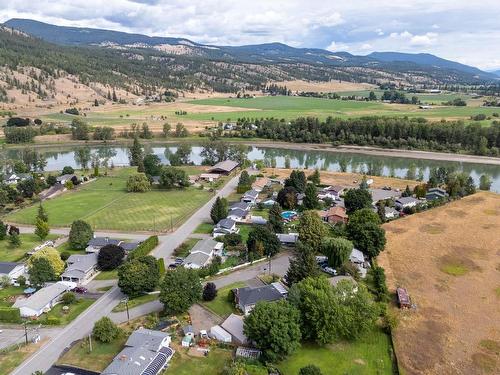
[101,328,174,375]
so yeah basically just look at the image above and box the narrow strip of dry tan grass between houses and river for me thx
[264,168,418,189]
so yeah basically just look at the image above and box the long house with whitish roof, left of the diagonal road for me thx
[14,282,69,318]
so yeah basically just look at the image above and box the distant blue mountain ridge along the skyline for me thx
[4,18,498,80]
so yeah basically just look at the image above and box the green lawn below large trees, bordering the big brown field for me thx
[278,330,392,375]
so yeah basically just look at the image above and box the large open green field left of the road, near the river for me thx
[7,168,211,231]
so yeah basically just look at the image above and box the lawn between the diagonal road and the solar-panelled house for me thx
[57,335,127,372]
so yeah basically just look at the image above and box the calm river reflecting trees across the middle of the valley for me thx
[6,144,500,193]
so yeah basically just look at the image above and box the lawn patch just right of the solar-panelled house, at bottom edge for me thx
[167,348,232,375]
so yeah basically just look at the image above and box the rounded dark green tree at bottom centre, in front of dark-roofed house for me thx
[243,300,301,362]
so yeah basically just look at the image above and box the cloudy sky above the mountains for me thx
[0,0,500,69]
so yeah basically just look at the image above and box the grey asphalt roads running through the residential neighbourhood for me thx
[11,175,239,375]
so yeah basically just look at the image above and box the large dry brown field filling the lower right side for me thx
[378,192,500,375]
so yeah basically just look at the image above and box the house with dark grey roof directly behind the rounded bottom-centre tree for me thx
[233,283,288,315]
